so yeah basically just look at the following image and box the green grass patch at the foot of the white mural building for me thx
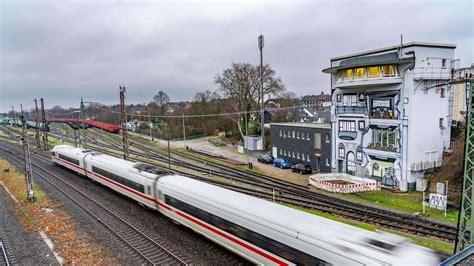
[344,190,458,224]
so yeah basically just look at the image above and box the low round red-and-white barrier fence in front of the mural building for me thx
[309,173,381,193]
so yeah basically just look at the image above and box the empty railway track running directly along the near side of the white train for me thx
[0,145,188,265]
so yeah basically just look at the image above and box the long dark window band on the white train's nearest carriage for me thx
[165,195,327,265]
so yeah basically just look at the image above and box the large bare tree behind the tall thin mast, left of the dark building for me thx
[214,63,285,138]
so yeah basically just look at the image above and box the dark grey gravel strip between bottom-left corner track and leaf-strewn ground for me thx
[0,186,59,265]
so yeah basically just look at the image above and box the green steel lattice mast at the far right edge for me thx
[454,78,474,253]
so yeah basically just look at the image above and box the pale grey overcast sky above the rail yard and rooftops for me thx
[0,0,474,112]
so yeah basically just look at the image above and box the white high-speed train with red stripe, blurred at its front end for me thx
[52,145,439,266]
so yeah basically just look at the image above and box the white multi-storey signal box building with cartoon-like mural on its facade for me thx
[323,42,456,191]
